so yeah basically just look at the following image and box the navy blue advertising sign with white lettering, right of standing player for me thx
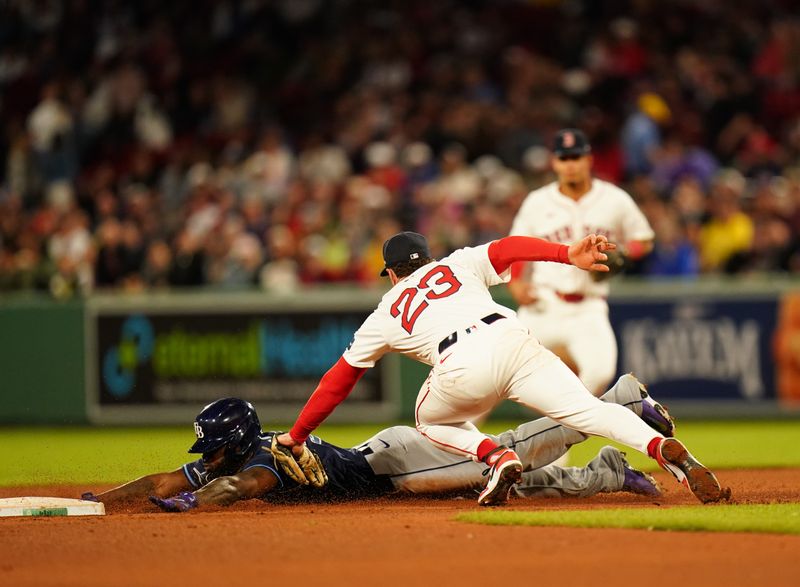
[611,299,777,402]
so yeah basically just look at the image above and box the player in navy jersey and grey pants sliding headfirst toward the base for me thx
[83,375,673,512]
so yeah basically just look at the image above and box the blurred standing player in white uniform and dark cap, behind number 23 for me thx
[509,129,654,395]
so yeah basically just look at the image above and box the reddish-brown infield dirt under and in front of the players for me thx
[0,469,800,587]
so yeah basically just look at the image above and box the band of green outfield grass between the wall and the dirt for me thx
[0,421,800,485]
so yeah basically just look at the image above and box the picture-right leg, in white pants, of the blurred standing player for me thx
[565,299,618,396]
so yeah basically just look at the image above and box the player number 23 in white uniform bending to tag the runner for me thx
[276,232,726,505]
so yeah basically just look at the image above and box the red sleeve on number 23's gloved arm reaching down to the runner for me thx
[289,357,366,444]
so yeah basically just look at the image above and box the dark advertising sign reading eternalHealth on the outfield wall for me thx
[89,310,395,422]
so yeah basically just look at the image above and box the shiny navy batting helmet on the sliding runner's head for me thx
[189,397,261,475]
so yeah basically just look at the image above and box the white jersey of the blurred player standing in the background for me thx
[511,179,654,297]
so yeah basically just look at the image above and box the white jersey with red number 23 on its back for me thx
[342,244,515,368]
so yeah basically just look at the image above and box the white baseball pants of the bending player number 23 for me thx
[415,318,660,460]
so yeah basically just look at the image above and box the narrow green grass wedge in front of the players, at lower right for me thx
[456,503,800,534]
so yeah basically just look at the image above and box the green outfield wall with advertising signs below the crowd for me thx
[0,280,800,424]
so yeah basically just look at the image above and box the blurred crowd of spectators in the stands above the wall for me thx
[0,0,800,296]
